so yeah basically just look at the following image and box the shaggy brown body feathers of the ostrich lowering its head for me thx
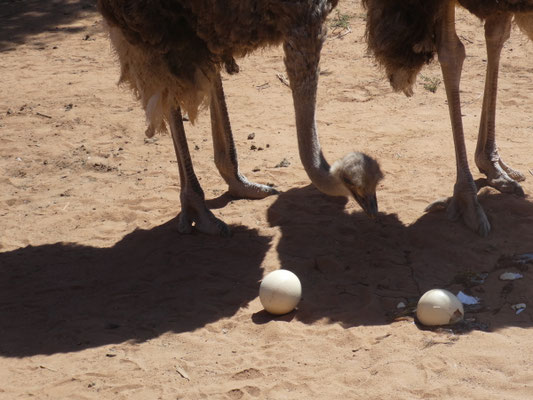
[98,0,337,136]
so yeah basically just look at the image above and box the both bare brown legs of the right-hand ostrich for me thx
[427,1,525,236]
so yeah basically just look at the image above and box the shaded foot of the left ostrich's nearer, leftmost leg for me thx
[178,195,231,237]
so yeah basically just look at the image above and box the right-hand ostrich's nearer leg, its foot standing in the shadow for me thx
[427,1,490,236]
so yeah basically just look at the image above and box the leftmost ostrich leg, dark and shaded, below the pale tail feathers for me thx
[170,108,230,236]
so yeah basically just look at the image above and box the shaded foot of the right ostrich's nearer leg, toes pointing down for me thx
[424,186,490,237]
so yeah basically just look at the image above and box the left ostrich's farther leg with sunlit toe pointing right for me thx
[210,74,278,199]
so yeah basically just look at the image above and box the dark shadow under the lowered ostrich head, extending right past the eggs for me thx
[266,186,533,330]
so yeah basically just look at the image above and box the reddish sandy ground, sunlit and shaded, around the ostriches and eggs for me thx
[0,0,533,400]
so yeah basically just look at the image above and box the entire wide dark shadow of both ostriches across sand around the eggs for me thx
[0,186,533,357]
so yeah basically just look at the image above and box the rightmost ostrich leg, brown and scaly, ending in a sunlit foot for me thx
[475,13,525,196]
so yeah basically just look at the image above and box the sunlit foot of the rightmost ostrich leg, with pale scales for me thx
[476,153,526,197]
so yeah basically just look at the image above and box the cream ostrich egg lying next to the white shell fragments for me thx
[416,289,465,326]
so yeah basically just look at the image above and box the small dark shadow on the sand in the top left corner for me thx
[0,0,96,52]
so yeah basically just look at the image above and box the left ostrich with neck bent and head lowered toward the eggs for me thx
[98,0,382,236]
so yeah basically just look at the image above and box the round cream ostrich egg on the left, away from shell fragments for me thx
[259,269,302,315]
